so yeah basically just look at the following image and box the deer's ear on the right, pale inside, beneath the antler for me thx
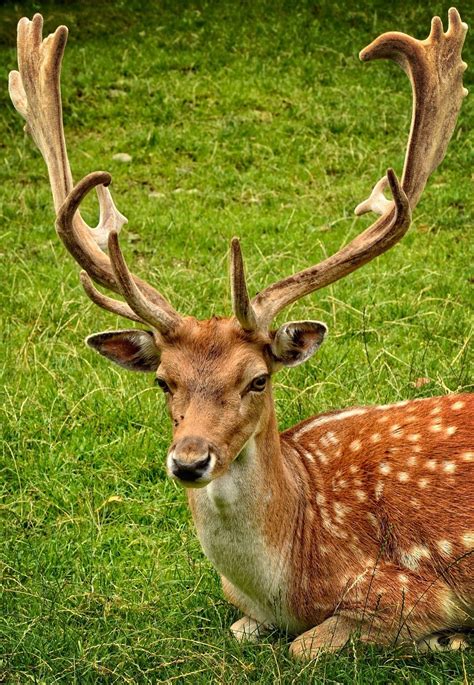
[271,321,328,366]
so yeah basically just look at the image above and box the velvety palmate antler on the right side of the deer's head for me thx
[231,8,467,329]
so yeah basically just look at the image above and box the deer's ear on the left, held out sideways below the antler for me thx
[86,329,160,372]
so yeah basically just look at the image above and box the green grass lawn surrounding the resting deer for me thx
[0,0,473,684]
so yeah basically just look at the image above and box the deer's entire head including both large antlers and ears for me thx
[10,9,467,487]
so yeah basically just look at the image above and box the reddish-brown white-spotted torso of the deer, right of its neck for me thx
[281,395,474,640]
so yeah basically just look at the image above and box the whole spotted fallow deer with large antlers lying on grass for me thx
[9,8,474,659]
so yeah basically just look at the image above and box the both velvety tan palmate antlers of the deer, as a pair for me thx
[10,9,467,334]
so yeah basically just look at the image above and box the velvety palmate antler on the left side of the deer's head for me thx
[9,14,181,333]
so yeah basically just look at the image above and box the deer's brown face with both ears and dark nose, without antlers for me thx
[87,317,327,487]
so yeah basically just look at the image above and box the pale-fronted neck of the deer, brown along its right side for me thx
[188,384,298,621]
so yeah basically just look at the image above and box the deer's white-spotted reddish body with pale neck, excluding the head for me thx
[188,374,474,646]
